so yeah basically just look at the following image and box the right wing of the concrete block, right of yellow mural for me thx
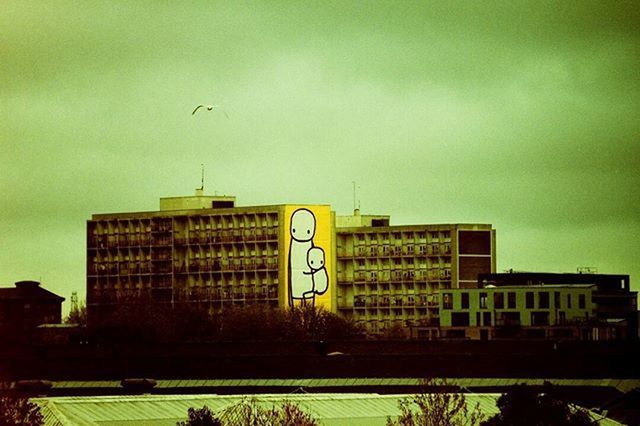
[336,212,495,339]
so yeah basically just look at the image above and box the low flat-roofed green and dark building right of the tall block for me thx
[439,273,637,340]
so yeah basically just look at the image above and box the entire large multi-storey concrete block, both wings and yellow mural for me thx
[87,190,496,338]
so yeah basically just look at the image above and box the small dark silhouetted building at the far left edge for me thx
[0,281,64,340]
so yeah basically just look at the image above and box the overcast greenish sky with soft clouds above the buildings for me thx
[0,0,640,310]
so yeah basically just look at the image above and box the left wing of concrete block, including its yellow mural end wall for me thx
[87,195,336,320]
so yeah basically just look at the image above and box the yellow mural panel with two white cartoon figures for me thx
[287,206,332,309]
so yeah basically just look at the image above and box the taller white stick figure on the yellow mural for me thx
[288,209,316,307]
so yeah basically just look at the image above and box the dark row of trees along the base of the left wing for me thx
[87,300,364,343]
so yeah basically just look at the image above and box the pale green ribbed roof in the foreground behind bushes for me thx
[32,393,619,425]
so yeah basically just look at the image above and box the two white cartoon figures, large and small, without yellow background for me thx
[288,208,329,307]
